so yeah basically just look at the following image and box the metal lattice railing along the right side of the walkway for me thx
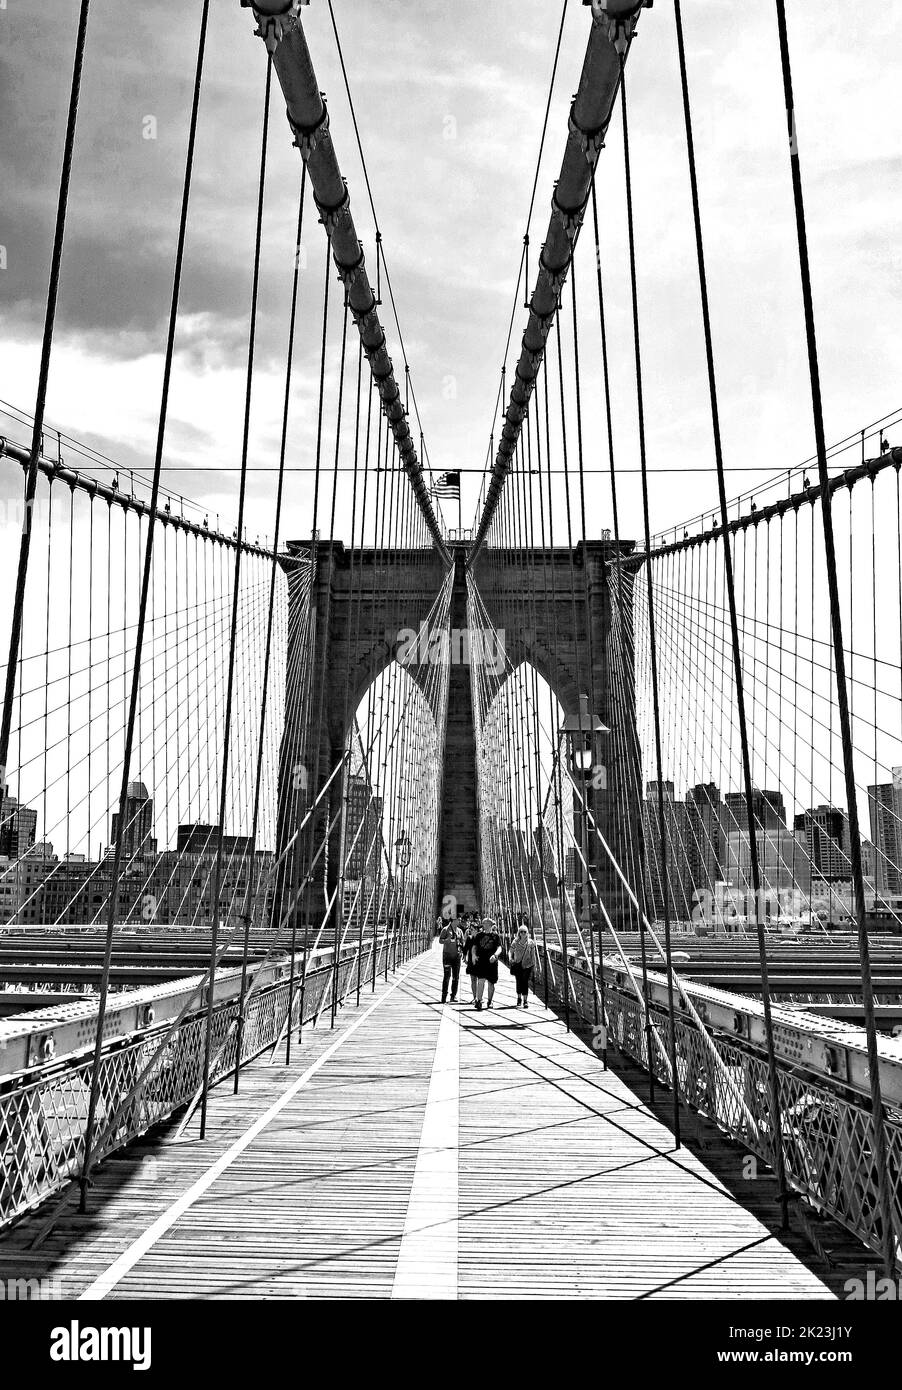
[535,947,902,1268]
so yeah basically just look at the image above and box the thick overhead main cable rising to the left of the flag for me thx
[240,0,452,567]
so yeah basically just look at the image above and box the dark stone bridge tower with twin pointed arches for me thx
[277,530,635,934]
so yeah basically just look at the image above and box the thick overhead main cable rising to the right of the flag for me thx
[468,0,650,564]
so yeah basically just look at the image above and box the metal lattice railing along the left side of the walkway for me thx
[0,934,428,1229]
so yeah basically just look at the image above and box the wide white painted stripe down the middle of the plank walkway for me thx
[392,1006,460,1298]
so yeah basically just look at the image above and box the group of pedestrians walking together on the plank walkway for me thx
[438,912,535,1012]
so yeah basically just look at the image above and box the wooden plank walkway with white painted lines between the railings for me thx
[0,951,845,1300]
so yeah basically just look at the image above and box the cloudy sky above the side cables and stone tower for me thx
[0,0,902,547]
